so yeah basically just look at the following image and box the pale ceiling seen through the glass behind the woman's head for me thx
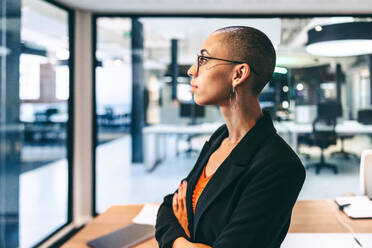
[94,17,362,68]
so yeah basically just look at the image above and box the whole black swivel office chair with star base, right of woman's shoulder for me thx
[306,117,338,174]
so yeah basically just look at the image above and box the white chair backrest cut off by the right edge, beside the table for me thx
[360,150,372,199]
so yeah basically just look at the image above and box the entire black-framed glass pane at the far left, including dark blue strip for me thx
[0,0,71,247]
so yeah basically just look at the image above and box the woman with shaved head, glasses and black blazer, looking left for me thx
[155,26,305,248]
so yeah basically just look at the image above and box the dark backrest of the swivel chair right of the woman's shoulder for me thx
[312,117,337,148]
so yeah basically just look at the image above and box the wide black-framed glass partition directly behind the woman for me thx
[95,16,371,212]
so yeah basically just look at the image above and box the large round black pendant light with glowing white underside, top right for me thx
[306,22,372,57]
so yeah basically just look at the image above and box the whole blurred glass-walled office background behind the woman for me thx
[0,0,372,247]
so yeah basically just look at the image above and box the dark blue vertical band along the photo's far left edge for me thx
[0,0,23,247]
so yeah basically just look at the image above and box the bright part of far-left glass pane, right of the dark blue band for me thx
[19,0,69,247]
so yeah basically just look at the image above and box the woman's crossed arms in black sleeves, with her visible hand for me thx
[156,165,305,248]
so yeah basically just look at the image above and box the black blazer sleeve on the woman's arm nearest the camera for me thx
[213,164,305,248]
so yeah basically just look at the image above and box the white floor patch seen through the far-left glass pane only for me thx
[19,160,68,247]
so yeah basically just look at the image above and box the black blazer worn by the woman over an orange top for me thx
[155,113,305,248]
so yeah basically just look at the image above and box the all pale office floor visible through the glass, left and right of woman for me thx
[20,135,372,247]
